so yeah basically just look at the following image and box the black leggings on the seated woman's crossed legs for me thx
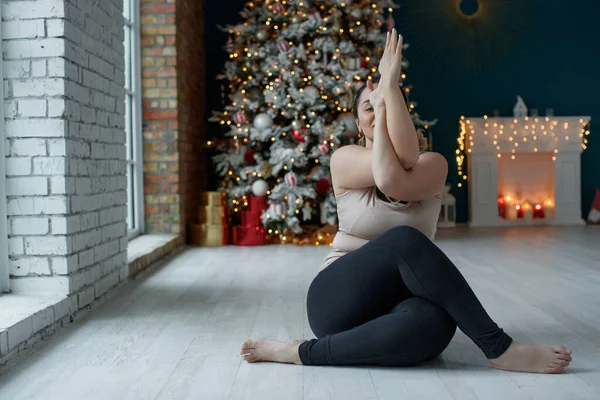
[299,226,512,367]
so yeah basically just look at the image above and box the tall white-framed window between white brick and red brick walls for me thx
[123,0,144,239]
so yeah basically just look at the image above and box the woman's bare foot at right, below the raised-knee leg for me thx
[490,341,571,374]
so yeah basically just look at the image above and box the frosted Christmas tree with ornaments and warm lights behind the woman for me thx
[211,0,435,242]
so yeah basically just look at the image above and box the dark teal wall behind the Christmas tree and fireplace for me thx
[205,0,600,221]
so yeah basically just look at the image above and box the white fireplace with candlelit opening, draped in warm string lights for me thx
[456,115,591,226]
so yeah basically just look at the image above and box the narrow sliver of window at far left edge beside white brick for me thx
[0,10,10,293]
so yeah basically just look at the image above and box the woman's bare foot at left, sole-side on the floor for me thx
[240,338,304,364]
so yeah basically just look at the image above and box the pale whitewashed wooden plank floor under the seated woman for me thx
[0,227,600,400]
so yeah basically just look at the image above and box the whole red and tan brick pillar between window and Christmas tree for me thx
[141,0,205,236]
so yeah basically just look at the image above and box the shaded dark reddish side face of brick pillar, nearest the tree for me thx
[176,0,207,243]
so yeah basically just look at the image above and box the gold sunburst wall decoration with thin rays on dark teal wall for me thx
[396,0,535,77]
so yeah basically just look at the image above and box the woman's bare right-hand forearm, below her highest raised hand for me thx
[380,83,420,170]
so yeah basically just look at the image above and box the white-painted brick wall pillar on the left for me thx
[2,0,128,300]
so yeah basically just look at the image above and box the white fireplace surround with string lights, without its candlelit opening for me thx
[458,117,590,227]
